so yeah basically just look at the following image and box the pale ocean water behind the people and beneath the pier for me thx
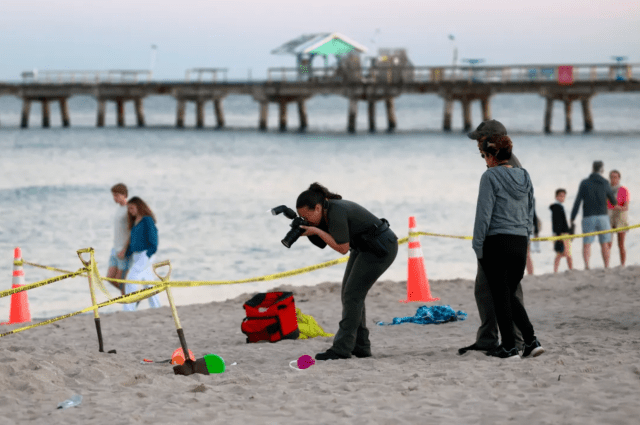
[0,94,640,320]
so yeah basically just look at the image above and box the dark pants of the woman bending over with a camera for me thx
[331,229,398,357]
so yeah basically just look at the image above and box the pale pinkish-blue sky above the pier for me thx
[0,0,640,81]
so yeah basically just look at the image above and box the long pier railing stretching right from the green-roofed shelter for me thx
[267,64,640,83]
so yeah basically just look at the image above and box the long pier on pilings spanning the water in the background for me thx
[0,63,640,133]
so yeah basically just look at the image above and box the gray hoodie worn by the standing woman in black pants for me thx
[471,166,534,259]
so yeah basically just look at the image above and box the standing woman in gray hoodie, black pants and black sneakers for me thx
[472,136,544,359]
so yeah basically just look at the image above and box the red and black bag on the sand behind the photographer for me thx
[241,292,300,343]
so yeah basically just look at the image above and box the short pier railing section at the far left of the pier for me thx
[21,69,153,84]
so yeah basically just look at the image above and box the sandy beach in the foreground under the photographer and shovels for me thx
[0,266,640,425]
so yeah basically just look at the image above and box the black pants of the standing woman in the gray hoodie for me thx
[480,235,534,350]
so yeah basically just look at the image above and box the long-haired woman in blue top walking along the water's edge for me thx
[118,196,160,311]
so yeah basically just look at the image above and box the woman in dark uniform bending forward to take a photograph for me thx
[296,183,398,360]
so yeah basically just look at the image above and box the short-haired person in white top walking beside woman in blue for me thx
[107,183,131,295]
